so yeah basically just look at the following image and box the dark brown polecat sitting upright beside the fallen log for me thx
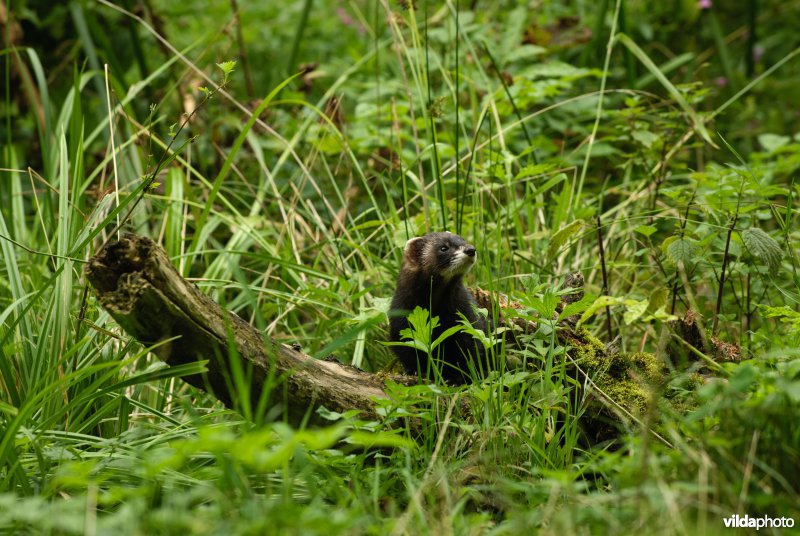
[390,233,486,383]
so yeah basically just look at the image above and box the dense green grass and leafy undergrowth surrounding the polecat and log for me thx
[0,0,800,534]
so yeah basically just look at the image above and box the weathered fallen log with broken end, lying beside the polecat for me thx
[86,234,640,425]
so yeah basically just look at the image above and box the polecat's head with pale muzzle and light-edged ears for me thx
[403,232,477,282]
